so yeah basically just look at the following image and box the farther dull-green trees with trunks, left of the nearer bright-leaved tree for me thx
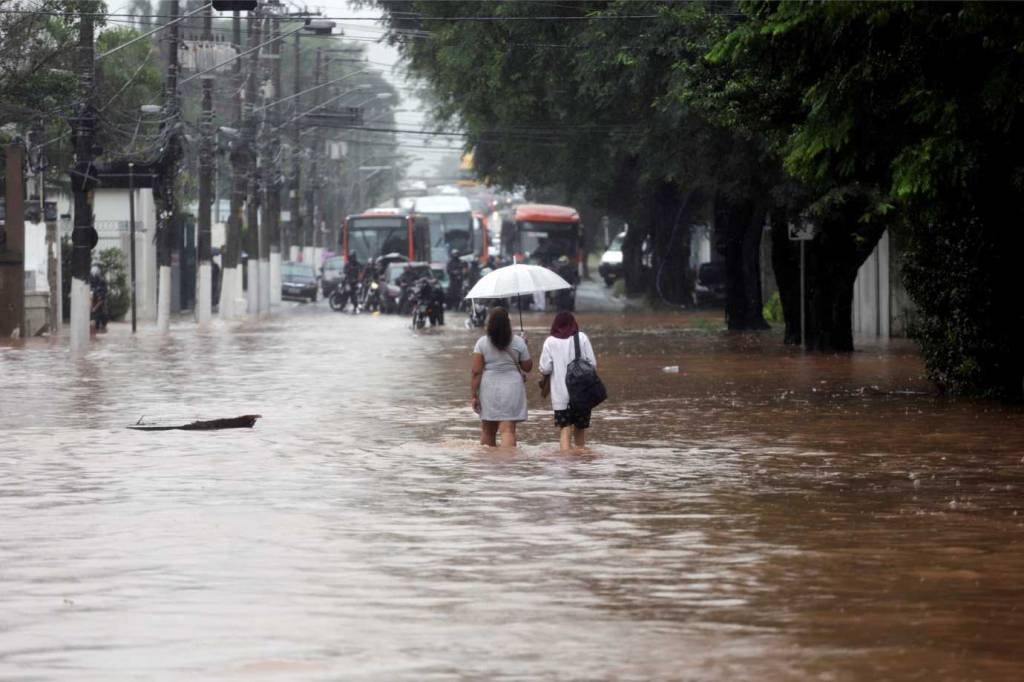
[380,2,764,329]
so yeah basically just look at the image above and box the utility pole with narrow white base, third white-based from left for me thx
[196,7,216,326]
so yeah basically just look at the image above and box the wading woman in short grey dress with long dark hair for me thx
[470,307,534,447]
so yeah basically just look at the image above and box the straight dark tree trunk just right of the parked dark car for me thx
[715,196,768,331]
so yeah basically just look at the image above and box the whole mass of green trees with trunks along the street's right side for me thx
[379,0,1024,397]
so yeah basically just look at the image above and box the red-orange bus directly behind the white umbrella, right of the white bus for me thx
[502,204,583,268]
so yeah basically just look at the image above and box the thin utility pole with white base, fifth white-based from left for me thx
[243,5,260,316]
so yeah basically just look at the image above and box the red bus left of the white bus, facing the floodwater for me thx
[341,209,430,263]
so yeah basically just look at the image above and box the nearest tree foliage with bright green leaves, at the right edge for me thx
[713,2,1024,396]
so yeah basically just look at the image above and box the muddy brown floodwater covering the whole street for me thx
[0,303,1024,681]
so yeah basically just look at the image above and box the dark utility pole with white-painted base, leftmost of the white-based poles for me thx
[68,2,98,353]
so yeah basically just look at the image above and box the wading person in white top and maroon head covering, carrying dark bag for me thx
[539,311,597,451]
